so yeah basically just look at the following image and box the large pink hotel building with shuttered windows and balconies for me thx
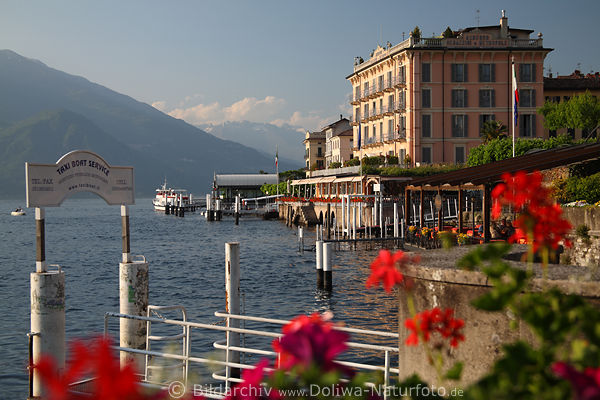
[347,12,552,166]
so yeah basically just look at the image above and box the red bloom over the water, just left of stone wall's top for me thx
[367,250,418,293]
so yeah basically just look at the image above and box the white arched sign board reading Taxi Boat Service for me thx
[25,150,135,207]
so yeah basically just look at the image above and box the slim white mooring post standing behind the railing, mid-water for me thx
[225,242,240,378]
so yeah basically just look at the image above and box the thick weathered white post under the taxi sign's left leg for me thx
[30,266,65,397]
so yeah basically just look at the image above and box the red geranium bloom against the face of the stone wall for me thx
[404,307,465,347]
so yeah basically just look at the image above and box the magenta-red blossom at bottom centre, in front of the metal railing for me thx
[273,313,349,371]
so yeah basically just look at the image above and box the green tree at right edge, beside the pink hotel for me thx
[538,91,600,136]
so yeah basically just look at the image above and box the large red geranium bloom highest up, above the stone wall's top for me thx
[492,171,571,251]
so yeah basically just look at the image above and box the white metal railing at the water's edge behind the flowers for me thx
[104,306,399,399]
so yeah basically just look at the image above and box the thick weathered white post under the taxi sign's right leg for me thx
[119,256,149,372]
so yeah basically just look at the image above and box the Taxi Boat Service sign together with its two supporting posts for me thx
[25,150,139,398]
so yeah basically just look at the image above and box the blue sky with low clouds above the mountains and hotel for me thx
[0,0,600,130]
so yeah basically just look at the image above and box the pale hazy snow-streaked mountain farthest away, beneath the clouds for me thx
[197,121,304,168]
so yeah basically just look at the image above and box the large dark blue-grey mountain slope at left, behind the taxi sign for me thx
[0,50,298,196]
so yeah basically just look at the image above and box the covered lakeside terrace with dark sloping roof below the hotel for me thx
[283,143,600,242]
